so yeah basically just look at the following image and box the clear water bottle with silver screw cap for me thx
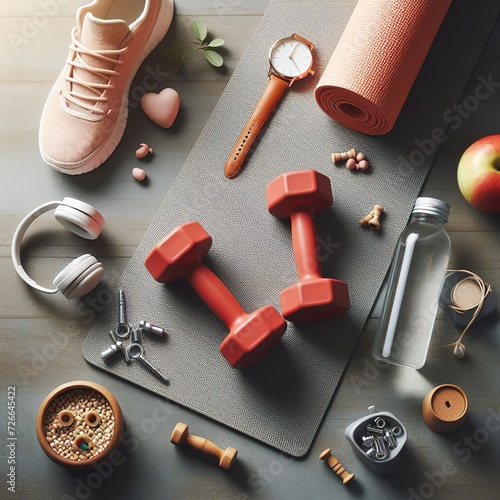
[372,198,451,369]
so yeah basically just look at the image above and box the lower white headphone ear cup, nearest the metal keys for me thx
[54,253,104,299]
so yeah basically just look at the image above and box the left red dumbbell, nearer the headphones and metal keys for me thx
[145,222,287,368]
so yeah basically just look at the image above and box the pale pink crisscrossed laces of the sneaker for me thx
[61,28,128,115]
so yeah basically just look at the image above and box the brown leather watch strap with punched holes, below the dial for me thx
[224,74,289,178]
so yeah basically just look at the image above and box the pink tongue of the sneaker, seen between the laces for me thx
[70,12,130,110]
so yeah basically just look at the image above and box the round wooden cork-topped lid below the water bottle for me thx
[422,384,469,432]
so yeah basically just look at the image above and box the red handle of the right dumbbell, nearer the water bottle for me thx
[290,208,321,281]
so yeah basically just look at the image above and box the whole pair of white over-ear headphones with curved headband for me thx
[11,197,104,299]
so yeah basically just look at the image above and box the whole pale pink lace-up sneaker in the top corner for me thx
[39,0,174,175]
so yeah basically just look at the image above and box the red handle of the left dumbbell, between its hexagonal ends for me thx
[184,262,247,330]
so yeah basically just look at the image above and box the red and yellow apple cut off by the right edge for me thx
[457,134,500,212]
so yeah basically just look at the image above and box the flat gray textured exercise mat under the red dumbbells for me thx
[83,0,500,456]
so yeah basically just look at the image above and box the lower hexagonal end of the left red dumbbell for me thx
[220,306,287,368]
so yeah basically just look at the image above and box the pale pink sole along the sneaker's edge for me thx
[40,0,174,175]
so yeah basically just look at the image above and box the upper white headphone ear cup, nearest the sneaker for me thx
[54,197,104,240]
